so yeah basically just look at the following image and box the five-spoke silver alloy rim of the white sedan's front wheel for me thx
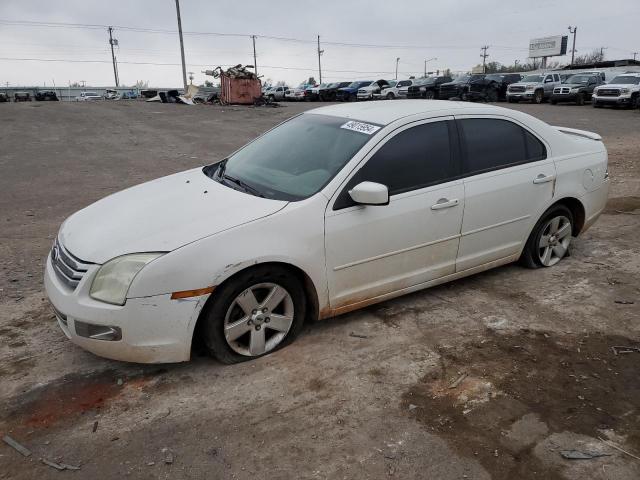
[224,283,294,357]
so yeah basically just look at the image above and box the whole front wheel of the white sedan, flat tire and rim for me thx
[201,265,307,364]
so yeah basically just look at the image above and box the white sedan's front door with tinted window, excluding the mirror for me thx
[325,118,464,313]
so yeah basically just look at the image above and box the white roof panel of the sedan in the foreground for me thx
[306,100,505,125]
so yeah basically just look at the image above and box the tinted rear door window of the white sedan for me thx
[459,118,547,175]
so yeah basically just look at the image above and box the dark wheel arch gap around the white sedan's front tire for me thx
[191,261,320,351]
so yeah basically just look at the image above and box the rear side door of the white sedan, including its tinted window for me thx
[456,116,556,271]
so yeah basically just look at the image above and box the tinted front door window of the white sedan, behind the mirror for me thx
[333,121,456,210]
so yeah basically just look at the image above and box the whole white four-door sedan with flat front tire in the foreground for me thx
[45,100,609,363]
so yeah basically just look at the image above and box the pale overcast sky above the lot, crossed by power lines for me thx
[0,0,640,87]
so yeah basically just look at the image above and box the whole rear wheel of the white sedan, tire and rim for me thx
[520,205,573,268]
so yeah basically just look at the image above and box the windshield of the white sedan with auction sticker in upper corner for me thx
[203,114,379,201]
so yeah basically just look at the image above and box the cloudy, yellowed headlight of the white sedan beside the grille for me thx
[89,253,164,305]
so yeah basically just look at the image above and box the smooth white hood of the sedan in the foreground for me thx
[59,168,288,264]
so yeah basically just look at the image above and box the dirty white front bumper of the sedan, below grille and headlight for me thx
[44,256,208,363]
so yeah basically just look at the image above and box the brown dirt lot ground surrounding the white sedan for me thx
[0,102,640,480]
